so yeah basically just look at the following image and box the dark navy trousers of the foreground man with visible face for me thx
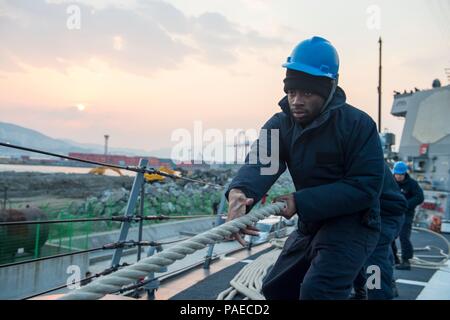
[262,215,380,300]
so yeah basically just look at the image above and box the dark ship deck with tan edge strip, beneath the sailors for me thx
[161,231,450,300]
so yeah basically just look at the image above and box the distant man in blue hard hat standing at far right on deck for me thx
[393,161,424,270]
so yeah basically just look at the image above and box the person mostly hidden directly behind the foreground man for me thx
[350,165,407,300]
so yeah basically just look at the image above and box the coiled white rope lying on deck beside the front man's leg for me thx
[217,239,286,300]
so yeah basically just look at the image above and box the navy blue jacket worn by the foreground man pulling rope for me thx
[226,87,384,228]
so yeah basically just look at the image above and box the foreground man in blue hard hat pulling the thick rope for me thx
[226,37,384,299]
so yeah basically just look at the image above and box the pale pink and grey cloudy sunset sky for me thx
[0,0,450,158]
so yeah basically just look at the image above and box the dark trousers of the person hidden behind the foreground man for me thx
[353,215,404,300]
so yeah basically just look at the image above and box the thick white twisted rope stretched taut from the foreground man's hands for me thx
[59,202,285,300]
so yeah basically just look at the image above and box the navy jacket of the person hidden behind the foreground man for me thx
[380,165,408,216]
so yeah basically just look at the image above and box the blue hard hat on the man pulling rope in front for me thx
[283,37,339,80]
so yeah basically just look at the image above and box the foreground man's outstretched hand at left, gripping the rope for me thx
[227,189,259,247]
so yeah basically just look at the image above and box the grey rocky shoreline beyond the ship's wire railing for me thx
[0,169,293,216]
